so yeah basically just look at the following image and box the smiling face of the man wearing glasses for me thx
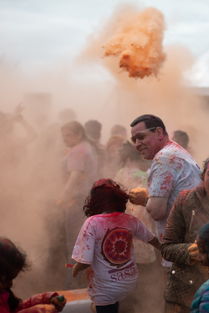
[131,122,164,160]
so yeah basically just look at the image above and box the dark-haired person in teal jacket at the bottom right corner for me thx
[191,224,209,313]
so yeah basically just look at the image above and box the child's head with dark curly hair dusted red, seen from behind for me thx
[83,178,129,216]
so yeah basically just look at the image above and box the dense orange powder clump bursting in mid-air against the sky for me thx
[103,8,165,78]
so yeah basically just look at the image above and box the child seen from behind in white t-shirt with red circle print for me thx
[72,179,160,313]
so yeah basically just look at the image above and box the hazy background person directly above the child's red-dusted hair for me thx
[84,120,105,178]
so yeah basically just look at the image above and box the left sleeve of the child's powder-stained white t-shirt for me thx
[72,217,95,264]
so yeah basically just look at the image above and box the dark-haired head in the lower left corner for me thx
[0,237,27,291]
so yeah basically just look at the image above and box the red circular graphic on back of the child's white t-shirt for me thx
[102,227,132,265]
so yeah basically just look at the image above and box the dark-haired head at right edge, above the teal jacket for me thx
[197,223,209,266]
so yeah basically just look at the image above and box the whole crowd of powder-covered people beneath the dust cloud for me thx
[0,107,209,313]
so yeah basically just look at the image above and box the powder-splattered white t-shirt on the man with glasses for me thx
[148,141,201,239]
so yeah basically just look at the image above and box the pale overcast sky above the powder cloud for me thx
[0,0,209,85]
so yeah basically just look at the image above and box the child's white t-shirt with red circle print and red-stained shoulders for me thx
[72,212,154,305]
